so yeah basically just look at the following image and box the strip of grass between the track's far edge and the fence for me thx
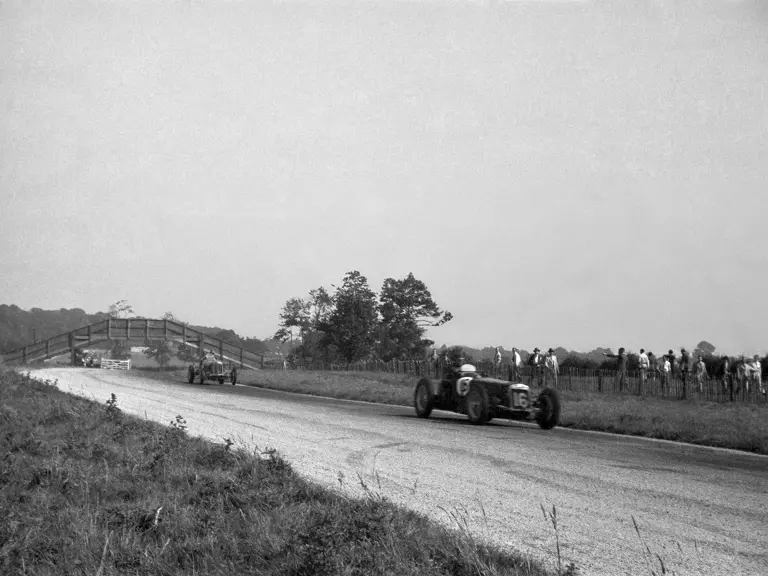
[124,370,768,454]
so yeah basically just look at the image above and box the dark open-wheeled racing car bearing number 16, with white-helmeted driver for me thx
[413,364,560,430]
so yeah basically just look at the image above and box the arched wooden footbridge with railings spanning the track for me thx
[0,318,264,369]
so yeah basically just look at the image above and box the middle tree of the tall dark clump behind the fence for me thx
[318,270,378,363]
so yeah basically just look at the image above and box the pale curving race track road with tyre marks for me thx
[30,369,768,576]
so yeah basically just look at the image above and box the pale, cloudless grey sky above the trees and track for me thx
[0,0,768,353]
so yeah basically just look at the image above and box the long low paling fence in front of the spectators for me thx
[264,360,766,403]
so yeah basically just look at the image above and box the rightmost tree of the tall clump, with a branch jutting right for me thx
[379,273,453,359]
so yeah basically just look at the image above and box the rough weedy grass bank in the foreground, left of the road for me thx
[0,371,560,576]
